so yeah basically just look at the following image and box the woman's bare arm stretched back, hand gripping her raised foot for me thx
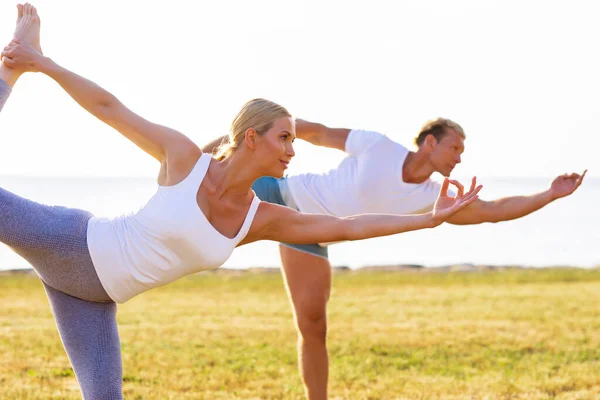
[2,41,195,162]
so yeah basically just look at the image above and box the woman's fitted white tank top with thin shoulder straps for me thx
[87,153,260,303]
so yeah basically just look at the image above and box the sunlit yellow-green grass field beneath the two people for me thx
[0,269,600,399]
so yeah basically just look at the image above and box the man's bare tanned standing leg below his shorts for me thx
[279,245,331,400]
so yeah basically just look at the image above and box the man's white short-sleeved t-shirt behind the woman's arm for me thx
[288,130,441,217]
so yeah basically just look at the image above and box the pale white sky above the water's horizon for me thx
[0,0,600,176]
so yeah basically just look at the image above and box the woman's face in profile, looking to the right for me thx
[256,117,296,178]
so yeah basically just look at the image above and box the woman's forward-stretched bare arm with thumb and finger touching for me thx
[242,178,482,244]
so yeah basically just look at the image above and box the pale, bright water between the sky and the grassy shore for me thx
[0,177,600,269]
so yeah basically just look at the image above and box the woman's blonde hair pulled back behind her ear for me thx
[215,99,292,161]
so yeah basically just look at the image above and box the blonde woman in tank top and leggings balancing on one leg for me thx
[0,4,481,399]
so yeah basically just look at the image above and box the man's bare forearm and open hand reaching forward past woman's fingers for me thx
[448,170,587,225]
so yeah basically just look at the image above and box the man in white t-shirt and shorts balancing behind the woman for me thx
[203,118,585,400]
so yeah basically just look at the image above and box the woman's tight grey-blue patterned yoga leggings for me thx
[0,80,123,400]
